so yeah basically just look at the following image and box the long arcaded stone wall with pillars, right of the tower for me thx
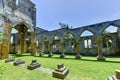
[35,20,120,59]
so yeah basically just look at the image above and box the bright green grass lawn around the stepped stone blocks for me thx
[0,55,120,80]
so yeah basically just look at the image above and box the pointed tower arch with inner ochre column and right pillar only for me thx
[10,22,35,53]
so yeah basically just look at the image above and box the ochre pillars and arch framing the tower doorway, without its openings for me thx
[0,22,35,59]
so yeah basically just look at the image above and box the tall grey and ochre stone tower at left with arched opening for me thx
[0,0,36,59]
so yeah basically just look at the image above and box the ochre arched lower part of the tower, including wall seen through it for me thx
[0,21,35,59]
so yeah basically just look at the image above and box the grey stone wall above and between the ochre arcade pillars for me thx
[35,19,120,55]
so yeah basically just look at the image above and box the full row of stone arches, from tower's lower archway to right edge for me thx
[1,20,120,60]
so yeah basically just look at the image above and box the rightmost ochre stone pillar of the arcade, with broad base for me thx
[97,37,105,60]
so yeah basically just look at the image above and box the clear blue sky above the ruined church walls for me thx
[31,0,120,31]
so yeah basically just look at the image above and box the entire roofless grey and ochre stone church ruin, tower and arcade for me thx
[0,0,120,59]
